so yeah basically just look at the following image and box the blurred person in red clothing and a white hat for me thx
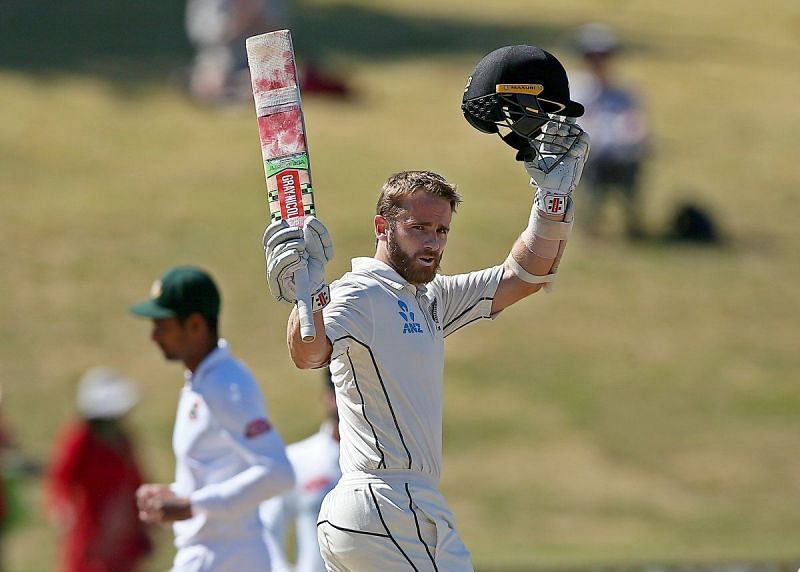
[47,367,151,572]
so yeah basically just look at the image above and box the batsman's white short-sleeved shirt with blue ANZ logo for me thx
[324,258,503,482]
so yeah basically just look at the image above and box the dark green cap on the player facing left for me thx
[128,266,220,320]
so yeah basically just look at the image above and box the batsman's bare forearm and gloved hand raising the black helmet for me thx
[492,121,589,314]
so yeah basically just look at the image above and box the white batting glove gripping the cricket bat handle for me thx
[262,216,333,311]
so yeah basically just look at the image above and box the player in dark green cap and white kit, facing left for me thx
[130,266,294,572]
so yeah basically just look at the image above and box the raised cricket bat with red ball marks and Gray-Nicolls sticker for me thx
[246,30,316,342]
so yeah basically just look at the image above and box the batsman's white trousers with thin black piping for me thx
[317,470,473,572]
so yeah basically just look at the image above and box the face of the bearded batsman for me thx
[386,192,453,284]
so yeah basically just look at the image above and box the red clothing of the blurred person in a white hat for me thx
[48,422,150,572]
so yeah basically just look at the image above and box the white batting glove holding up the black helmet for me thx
[524,118,589,215]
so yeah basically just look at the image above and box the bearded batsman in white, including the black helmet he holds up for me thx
[264,46,589,571]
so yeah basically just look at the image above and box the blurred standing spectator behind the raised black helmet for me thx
[571,23,649,238]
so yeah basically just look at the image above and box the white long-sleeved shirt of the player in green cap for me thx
[171,340,294,570]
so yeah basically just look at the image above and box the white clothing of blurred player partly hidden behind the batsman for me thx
[261,423,342,572]
